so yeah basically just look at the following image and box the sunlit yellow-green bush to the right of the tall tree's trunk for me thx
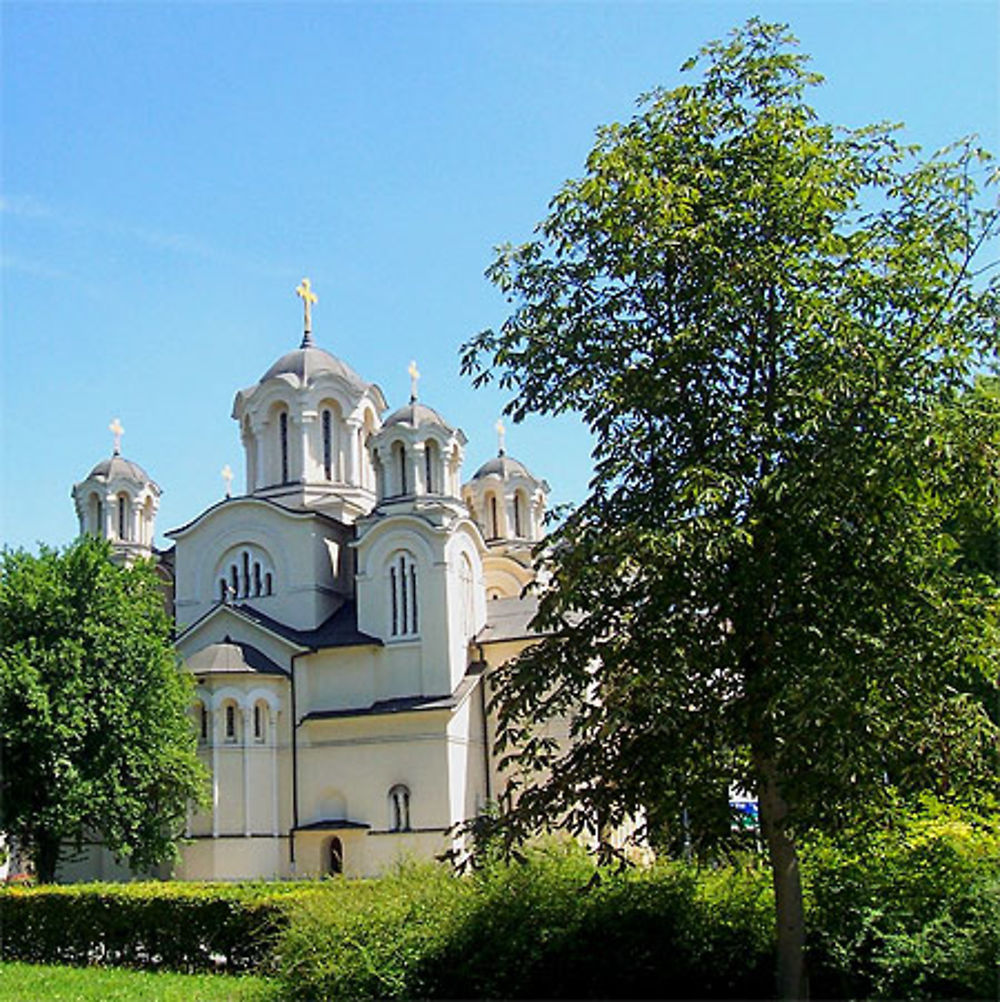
[805,798,1000,999]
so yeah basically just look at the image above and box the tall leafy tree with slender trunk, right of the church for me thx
[462,20,1000,997]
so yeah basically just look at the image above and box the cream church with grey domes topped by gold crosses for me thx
[65,280,548,880]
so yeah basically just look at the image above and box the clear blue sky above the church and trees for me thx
[0,0,1000,547]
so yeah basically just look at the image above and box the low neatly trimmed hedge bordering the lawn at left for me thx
[0,883,302,972]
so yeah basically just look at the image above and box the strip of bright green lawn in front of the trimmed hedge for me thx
[0,964,278,1002]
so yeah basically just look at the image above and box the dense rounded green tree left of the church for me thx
[0,537,203,882]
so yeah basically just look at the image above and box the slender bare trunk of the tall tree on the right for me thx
[760,762,809,999]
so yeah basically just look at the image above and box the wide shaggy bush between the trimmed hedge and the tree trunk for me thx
[277,846,773,1000]
